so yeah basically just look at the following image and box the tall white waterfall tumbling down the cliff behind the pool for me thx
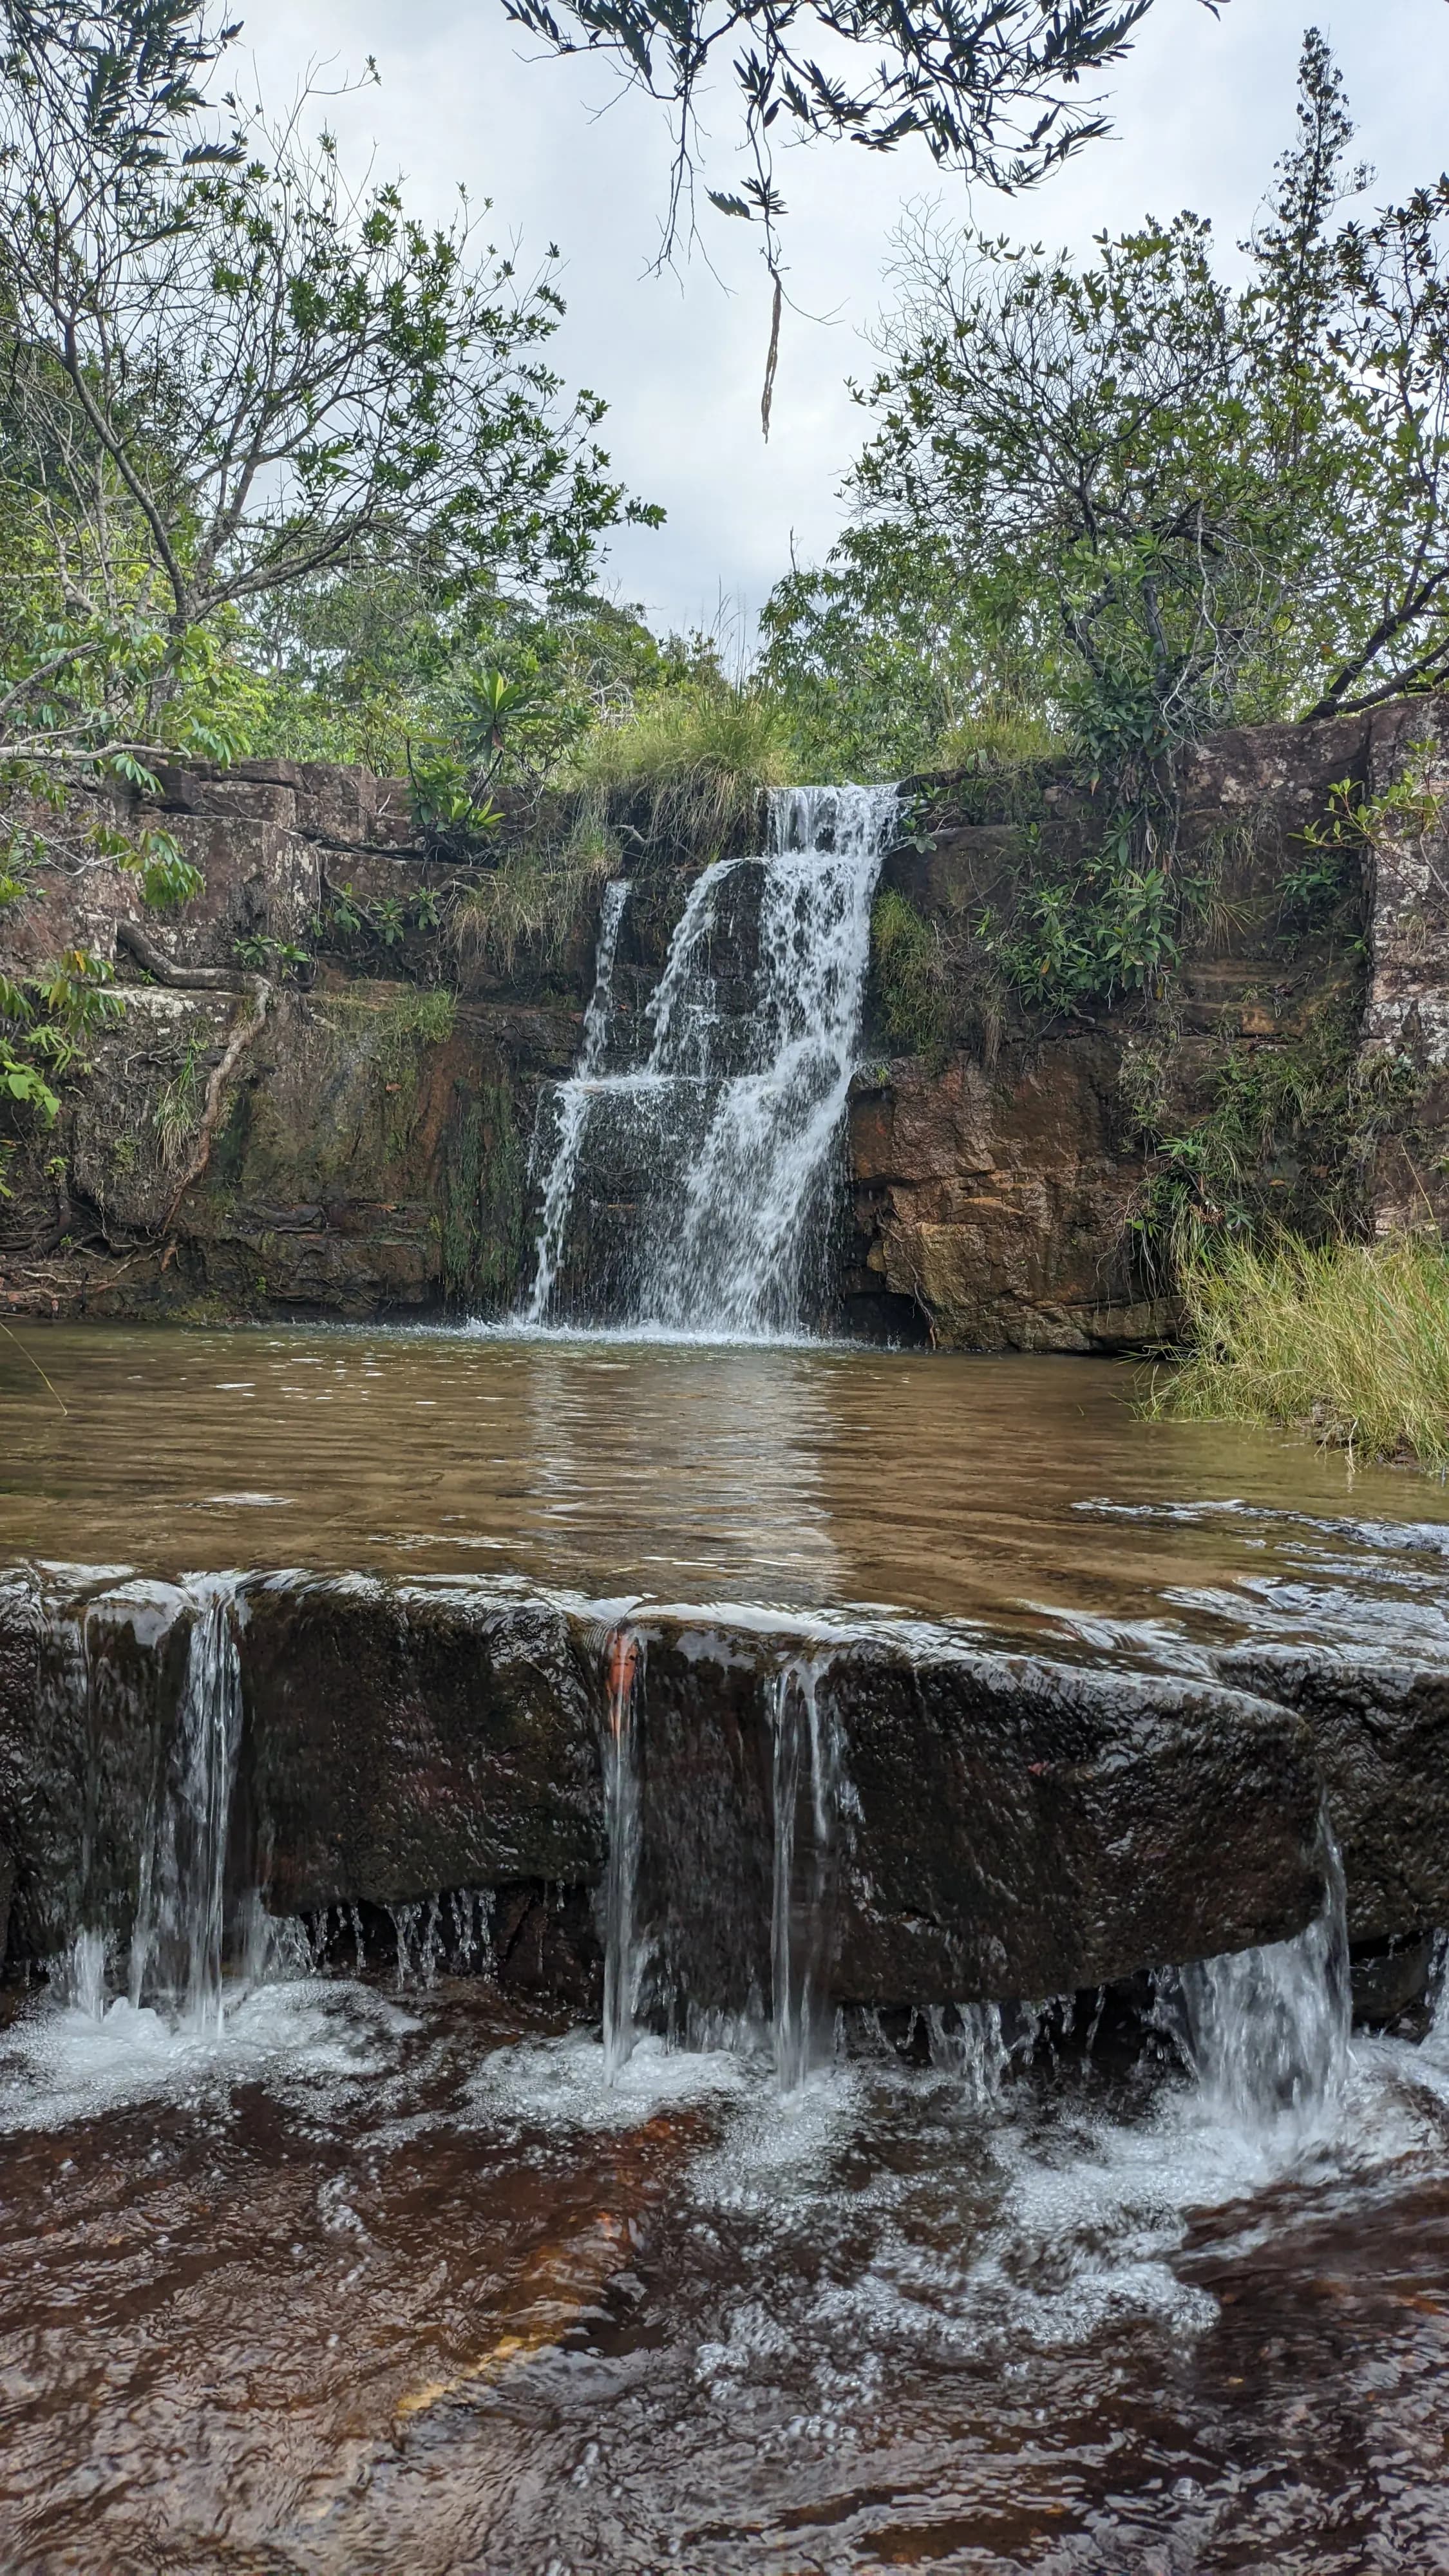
[513,788,897,1340]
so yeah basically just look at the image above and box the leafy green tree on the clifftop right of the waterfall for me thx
[768,31,1449,778]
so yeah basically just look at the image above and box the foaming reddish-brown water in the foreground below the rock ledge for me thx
[0,1984,1449,2576]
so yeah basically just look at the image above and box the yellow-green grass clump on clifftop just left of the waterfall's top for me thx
[565,683,791,850]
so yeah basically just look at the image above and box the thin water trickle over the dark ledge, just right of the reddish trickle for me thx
[771,1664,840,2094]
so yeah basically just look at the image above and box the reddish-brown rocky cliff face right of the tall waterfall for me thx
[846,701,1449,1352]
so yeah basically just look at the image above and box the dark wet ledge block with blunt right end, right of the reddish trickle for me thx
[637,1623,1325,2020]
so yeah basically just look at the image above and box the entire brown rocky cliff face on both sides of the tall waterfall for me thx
[0,701,1449,1350]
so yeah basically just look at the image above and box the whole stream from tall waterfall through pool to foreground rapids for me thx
[0,788,1449,2576]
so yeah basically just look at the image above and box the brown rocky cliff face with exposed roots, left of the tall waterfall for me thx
[0,762,591,1316]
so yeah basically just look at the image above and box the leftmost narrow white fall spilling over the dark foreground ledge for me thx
[129,1574,242,2032]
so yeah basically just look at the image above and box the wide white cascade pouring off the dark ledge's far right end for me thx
[1160,1829,1354,2136]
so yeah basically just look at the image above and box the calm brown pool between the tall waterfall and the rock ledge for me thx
[0,1324,1449,1654]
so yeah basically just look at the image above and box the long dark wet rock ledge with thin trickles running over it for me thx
[0,1569,1340,2027]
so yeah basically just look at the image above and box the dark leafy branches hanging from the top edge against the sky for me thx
[503,0,1220,265]
